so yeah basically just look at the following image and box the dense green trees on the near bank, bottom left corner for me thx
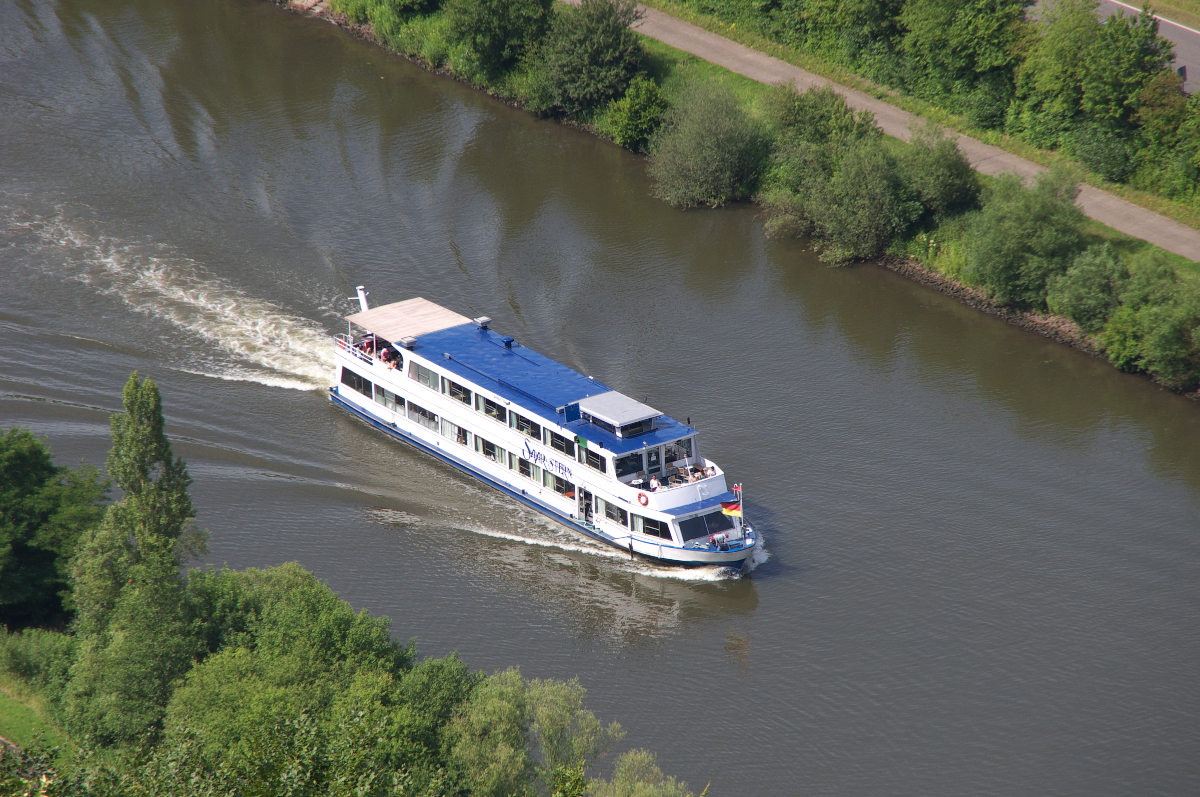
[0,372,708,797]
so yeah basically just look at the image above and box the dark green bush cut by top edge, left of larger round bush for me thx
[444,0,553,84]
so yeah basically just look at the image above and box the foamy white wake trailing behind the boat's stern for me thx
[12,208,334,390]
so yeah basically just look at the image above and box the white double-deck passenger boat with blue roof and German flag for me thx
[329,287,757,569]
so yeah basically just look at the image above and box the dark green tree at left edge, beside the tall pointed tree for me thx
[0,426,108,627]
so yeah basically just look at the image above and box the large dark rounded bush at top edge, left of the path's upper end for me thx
[527,0,646,119]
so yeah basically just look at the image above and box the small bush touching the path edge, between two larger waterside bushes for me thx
[899,122,979,222]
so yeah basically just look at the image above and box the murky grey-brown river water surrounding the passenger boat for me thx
[0,0,1200,796]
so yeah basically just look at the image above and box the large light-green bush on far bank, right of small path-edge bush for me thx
[965,172,1082,310]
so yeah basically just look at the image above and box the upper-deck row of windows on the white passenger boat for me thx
[342,361,692,479]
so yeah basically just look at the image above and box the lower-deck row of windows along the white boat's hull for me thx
[342,367,671,540]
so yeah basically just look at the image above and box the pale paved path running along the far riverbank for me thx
[635,7,1200,262]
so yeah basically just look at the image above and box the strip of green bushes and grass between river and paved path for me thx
[275,0,1200,400]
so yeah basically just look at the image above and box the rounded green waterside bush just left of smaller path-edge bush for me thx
[804,139,922,265]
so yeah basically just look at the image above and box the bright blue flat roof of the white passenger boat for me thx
[413,323,696,455]
